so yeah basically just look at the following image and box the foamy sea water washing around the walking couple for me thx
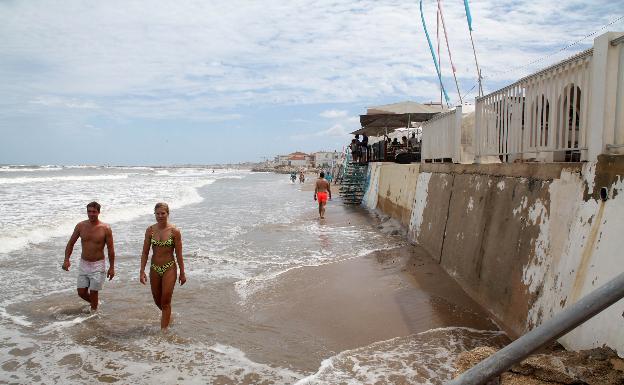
[0,165,500,384]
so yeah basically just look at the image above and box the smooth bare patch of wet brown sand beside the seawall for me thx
[241,196,498,370]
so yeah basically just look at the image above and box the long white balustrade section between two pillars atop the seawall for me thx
[475,49,593,162]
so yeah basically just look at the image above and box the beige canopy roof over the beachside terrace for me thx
[351,101,443,136]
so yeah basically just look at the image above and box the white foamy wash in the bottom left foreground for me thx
[0,328,305,385]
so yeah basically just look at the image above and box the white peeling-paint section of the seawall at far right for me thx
[523,156,624,356]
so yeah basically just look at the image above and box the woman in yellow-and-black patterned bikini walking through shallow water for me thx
[139,203,186,329]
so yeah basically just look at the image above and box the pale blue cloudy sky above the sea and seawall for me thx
[0,0,624,165]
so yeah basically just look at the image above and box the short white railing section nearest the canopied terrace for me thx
[421,106,462,163]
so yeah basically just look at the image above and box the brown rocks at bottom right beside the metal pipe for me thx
[455,346,624,385]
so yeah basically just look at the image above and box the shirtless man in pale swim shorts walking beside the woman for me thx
[63,202,115,311]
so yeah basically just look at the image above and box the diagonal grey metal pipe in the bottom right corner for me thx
[446,273,624,385]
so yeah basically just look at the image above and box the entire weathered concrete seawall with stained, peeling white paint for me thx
[366,156,624,355]
